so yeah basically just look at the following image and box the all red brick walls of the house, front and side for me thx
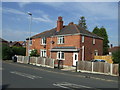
[26,35,103,66]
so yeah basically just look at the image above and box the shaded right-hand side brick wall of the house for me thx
[80,36,103,60]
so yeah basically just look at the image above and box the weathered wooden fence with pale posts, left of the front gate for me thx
[17,56,54,68]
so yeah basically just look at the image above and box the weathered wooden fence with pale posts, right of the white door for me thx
[76,61,119,76]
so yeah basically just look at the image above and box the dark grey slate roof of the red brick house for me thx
[26,24,103,40]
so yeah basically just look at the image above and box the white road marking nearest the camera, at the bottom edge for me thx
[53,82,92,89]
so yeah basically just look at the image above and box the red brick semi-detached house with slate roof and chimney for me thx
[26,16,103,66]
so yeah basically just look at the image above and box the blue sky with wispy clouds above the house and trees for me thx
[0,2,118,46]
